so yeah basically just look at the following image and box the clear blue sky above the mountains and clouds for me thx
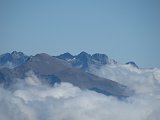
[0,0,160,67]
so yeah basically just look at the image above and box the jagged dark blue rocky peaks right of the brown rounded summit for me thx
[57,52,117,71]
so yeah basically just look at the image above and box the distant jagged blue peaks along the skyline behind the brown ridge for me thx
[0,51,138,71]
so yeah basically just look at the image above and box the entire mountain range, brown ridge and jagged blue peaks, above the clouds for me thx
[0,51,138,98]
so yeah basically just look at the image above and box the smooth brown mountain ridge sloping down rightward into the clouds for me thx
[0,53,130,97]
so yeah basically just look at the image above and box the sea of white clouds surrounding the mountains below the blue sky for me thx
[0,65,160,120]
